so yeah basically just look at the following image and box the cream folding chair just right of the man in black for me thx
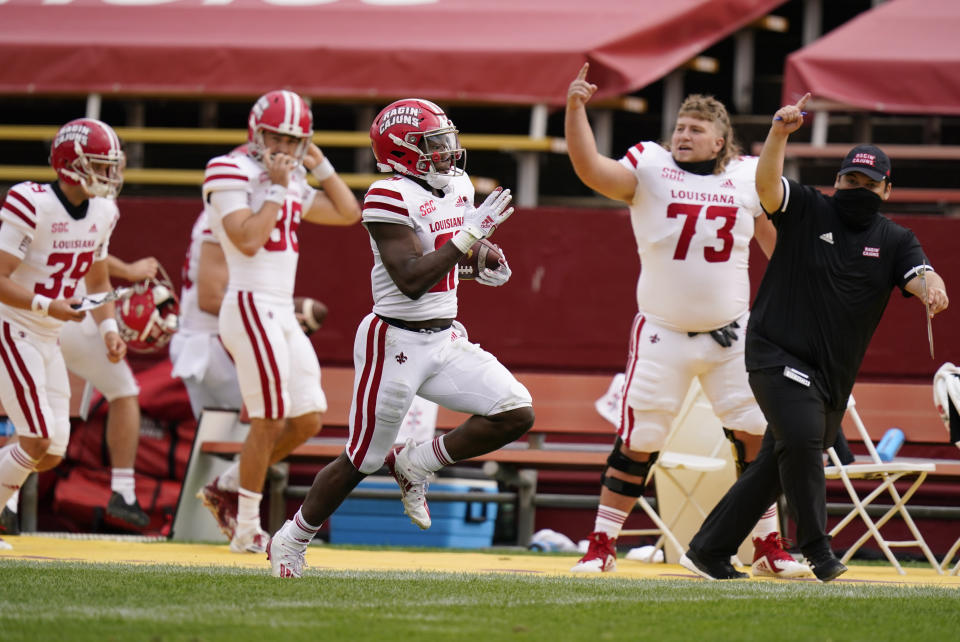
[824,395,943,575]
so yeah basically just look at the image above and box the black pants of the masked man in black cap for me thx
[690,368,844,558]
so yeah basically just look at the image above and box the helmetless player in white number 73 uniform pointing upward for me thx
[565,64,809,577]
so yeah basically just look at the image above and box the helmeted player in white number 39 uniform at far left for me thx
[0,118,126,548]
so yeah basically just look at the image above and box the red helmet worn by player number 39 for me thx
[50,118,127,198]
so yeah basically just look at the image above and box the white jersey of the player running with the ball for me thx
[363,174,474,321]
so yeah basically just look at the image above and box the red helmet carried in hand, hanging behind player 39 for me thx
[116,270,180,354]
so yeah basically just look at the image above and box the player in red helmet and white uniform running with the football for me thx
[268,99,533,577]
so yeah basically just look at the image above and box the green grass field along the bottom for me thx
[0,560,960,642]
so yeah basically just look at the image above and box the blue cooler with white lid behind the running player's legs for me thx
[330,477,497,548]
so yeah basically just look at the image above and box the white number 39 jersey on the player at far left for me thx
[0,182,120,337]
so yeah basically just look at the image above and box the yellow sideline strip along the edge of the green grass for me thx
[0,536,960,588]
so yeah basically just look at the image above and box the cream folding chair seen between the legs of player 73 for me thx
[620,380,736,563]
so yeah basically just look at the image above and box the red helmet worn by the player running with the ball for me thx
[370,98,467,188]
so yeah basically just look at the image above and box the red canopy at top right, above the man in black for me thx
[783,0,960,115]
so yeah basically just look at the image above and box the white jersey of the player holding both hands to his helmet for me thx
[203,154,316,303]
